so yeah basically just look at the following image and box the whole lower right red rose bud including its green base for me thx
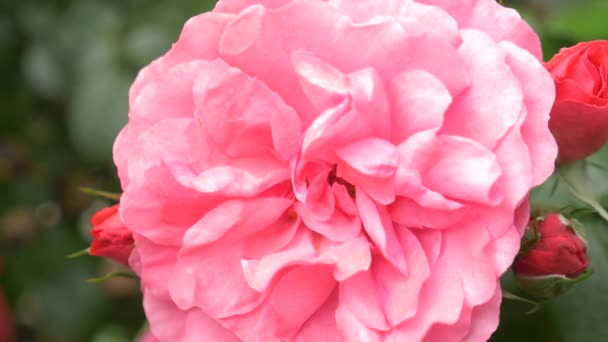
[513,213,591,298]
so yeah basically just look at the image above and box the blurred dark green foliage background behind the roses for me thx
[0,0,608,342]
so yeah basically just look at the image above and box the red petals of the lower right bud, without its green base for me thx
[513,213,589,278]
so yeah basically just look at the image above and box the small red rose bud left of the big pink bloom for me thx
[89,204,134,265]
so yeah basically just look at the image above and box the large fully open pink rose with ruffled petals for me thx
[114,0,557,342]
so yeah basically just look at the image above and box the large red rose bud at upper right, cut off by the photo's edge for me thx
[545,40,608,162]
